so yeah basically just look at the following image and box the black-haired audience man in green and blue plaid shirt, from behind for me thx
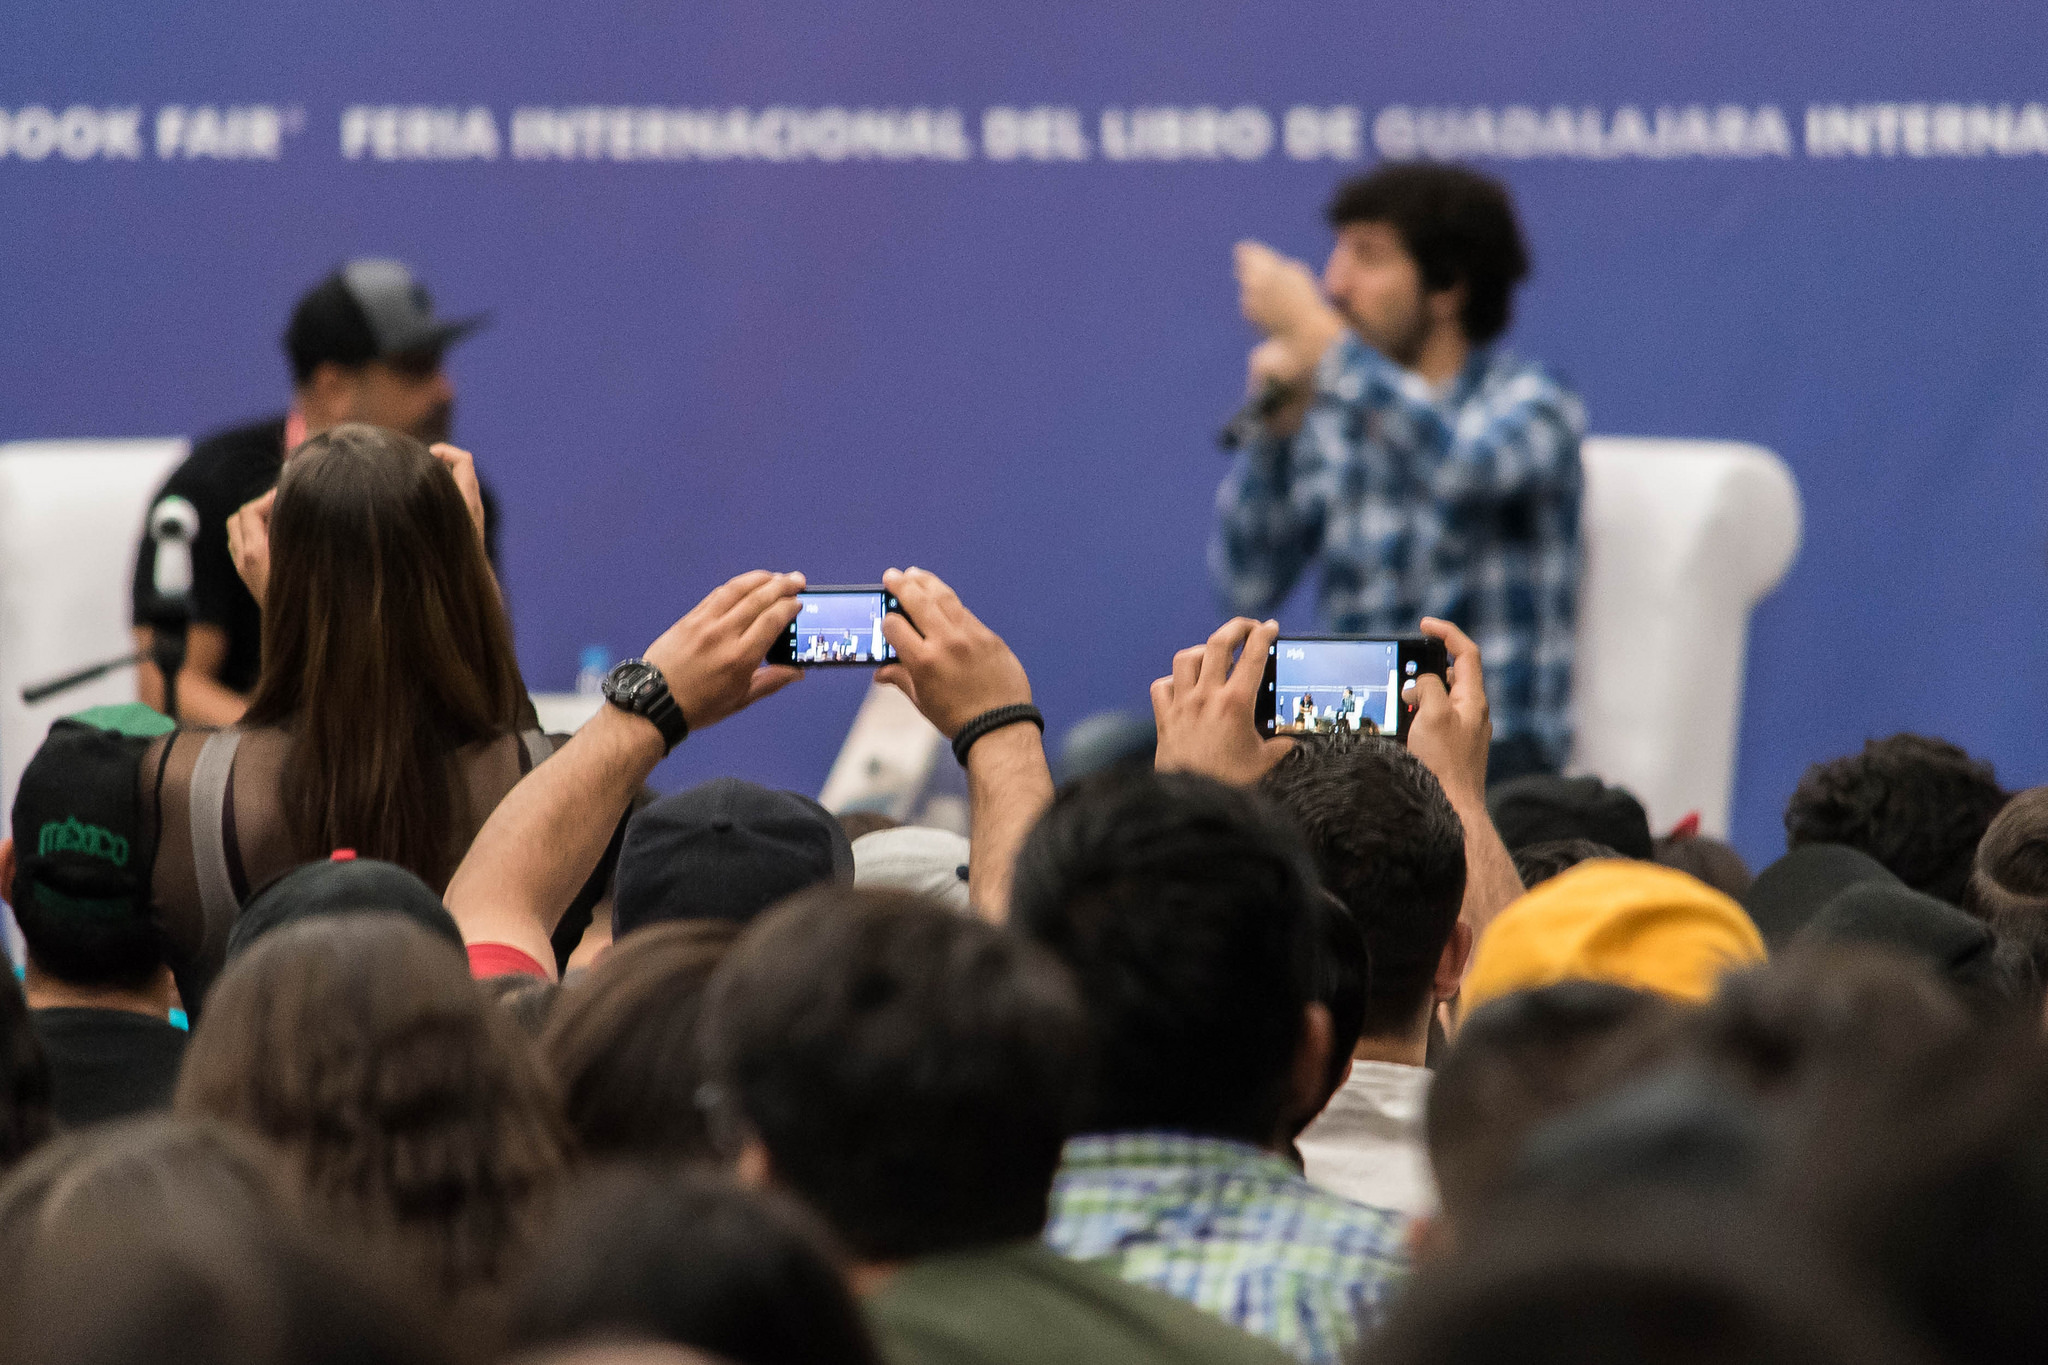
[1010,773,1407,1365]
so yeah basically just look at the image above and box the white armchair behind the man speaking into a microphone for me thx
[1571,436,1800,837]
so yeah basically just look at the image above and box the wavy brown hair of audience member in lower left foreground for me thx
[172,915,569,1300]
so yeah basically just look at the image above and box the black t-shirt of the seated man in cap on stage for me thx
[133,415,498,692]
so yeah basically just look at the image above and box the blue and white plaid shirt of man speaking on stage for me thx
[1208,334,1585,763]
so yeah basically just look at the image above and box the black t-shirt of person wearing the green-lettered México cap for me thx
[29,1007,184,1128]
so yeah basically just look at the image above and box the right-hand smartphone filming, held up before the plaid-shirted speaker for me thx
[1257,634,1450,743]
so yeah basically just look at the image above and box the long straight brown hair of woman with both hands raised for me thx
[244,424,524,890]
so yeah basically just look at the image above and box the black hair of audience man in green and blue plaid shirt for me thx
[1010,772,1327,1146]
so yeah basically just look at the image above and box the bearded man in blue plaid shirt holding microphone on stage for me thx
[1208,166,1585,780]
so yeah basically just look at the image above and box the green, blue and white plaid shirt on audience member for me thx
[1044,1132,1407,1365]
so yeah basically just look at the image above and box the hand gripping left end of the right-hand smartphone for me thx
[1151,616,1294,786]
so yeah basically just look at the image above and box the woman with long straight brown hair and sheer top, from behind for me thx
[141,424,547,986]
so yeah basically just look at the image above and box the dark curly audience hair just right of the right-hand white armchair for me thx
[1786,735,2007,905]
